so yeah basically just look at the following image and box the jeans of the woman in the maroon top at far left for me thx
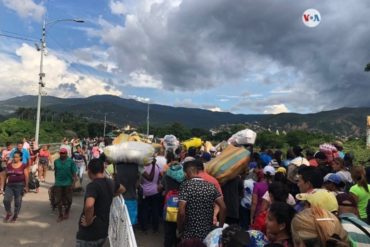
[4,183,24,217]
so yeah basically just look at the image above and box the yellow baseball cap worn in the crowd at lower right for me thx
[296,189,338,212]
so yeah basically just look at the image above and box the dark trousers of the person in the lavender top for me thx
[140,193,161,231]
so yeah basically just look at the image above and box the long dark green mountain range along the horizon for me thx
[0,95,370,137]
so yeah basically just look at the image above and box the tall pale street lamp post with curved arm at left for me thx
[35,19,84,145]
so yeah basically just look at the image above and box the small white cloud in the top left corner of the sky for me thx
[2,0,46,21]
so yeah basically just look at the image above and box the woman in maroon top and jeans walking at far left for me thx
[4,151,29,223]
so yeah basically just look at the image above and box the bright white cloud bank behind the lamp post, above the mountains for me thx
[0,44,122,98]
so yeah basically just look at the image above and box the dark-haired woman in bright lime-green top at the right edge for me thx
[349,166,370,222]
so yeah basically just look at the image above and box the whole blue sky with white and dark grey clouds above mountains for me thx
[0,0,370,114]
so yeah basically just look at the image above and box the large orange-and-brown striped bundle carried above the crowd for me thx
[205,145,250,183]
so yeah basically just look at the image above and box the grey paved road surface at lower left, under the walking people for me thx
[0,171,163,247]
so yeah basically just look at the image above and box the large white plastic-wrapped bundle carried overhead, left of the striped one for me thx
[104,142,154,165]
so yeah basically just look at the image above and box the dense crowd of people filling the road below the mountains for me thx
[0,135,370,247]
